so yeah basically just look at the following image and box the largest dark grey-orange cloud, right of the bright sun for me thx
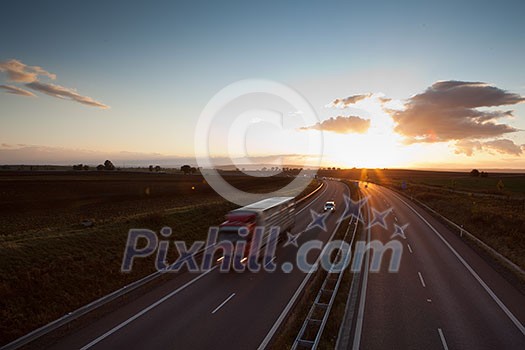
[389,81,525,143]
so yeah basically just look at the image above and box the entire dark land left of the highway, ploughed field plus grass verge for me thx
[0,172,316,344]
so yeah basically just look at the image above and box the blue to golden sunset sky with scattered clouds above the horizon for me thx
[0,0,525,169]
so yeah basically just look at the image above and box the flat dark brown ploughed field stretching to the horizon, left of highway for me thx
[0,172,302,235]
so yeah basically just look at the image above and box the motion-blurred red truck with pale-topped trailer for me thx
[217,197,295,256]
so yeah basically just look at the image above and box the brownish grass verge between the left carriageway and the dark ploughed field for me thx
[0,202,235,343]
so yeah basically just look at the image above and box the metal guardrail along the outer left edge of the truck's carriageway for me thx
[0,183,324,350]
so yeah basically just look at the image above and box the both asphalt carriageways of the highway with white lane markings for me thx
[33,181,525,350]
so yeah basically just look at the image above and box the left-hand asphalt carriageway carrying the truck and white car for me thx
[46,181,349,349]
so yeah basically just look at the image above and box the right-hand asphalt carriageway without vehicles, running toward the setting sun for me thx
[347,184,525,350]
